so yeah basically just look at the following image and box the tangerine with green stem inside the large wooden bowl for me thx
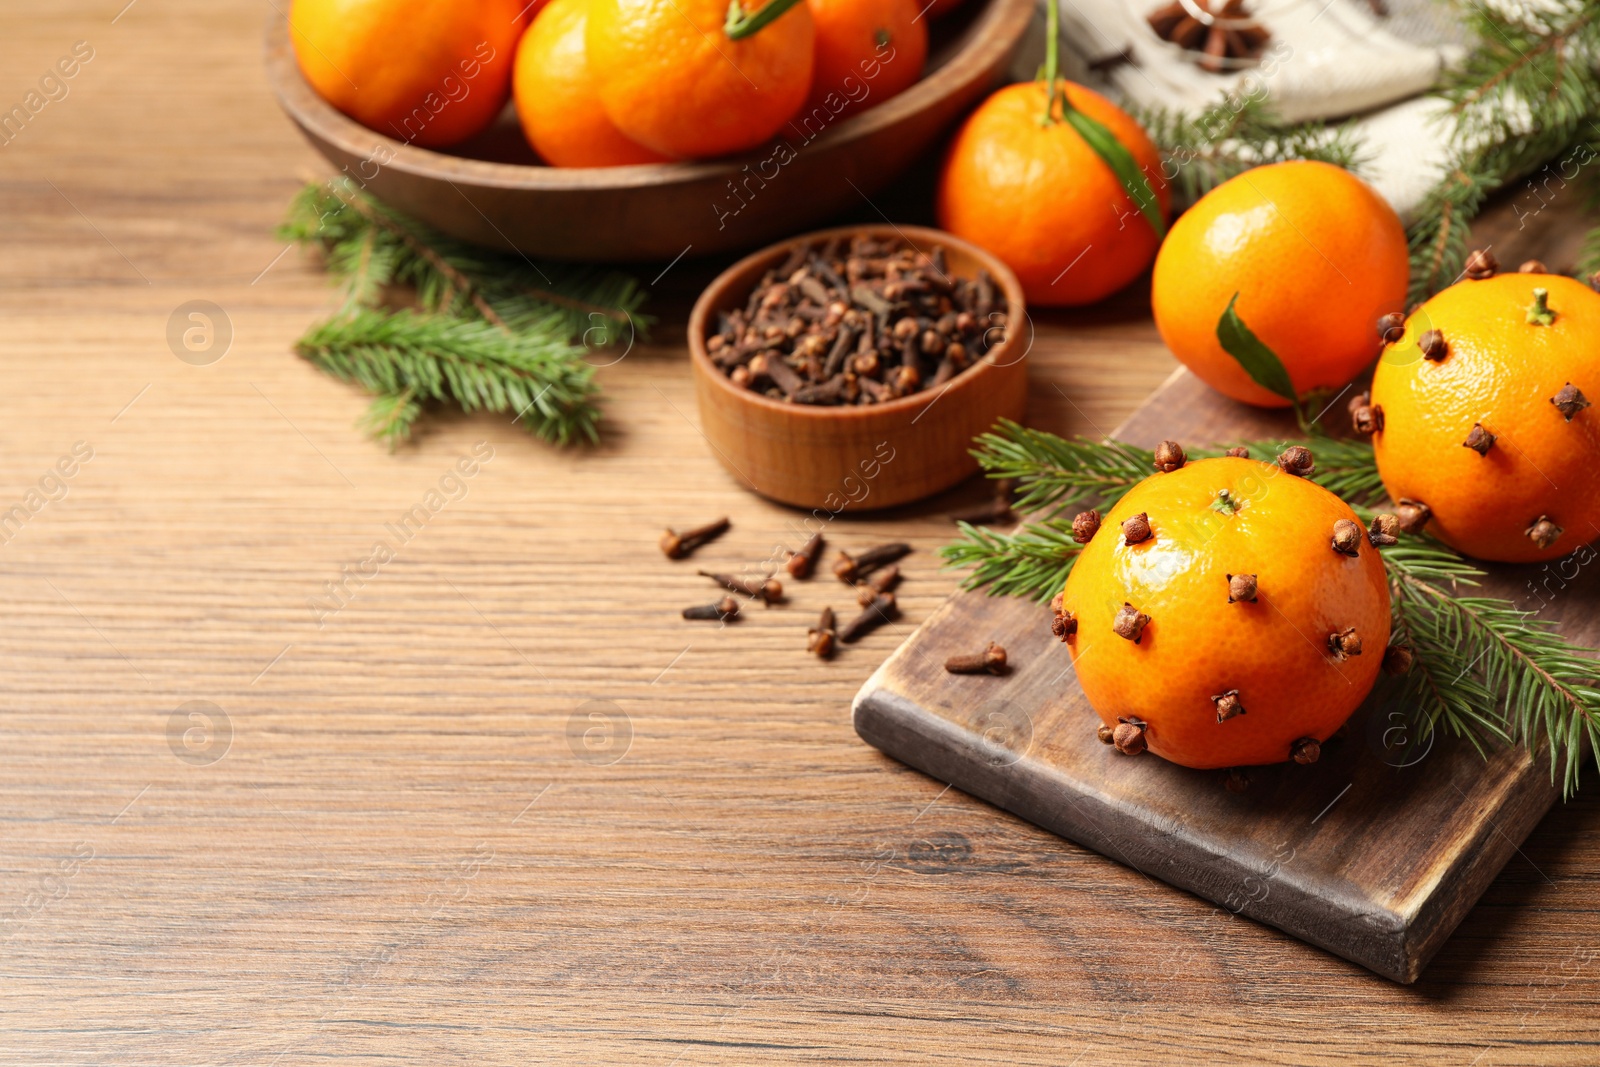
[584,0,816,158]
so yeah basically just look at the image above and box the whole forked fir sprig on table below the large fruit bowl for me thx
[278,179,650,448]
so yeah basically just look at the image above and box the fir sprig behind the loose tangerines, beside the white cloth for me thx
[1134,98,1368,203]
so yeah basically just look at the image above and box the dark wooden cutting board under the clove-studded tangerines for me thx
[854,371,1600,982]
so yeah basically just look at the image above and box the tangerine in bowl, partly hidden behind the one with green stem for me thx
[512,0,667,166]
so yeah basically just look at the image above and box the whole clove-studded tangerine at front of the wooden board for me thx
[1054,458,1389,768]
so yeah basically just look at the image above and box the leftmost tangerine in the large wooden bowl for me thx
[290,0,525,147]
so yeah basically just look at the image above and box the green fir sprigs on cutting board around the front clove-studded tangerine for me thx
[942,422,1600,795]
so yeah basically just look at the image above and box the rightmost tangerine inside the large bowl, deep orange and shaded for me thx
[805,0,928,115]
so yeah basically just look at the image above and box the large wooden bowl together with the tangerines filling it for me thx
[267,0,1032,261]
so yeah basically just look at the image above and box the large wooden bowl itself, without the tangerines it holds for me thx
[267,0,1034,262]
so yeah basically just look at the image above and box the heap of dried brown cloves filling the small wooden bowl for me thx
[706,235,1006,405]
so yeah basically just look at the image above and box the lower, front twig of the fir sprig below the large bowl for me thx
[296,307,600,445]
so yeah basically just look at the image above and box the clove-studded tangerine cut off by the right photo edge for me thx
[1371,267,1600,563]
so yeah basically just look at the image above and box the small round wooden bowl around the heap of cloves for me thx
[690,226,1032,515]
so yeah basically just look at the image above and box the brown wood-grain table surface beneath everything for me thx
[0,0,1600,1067]
